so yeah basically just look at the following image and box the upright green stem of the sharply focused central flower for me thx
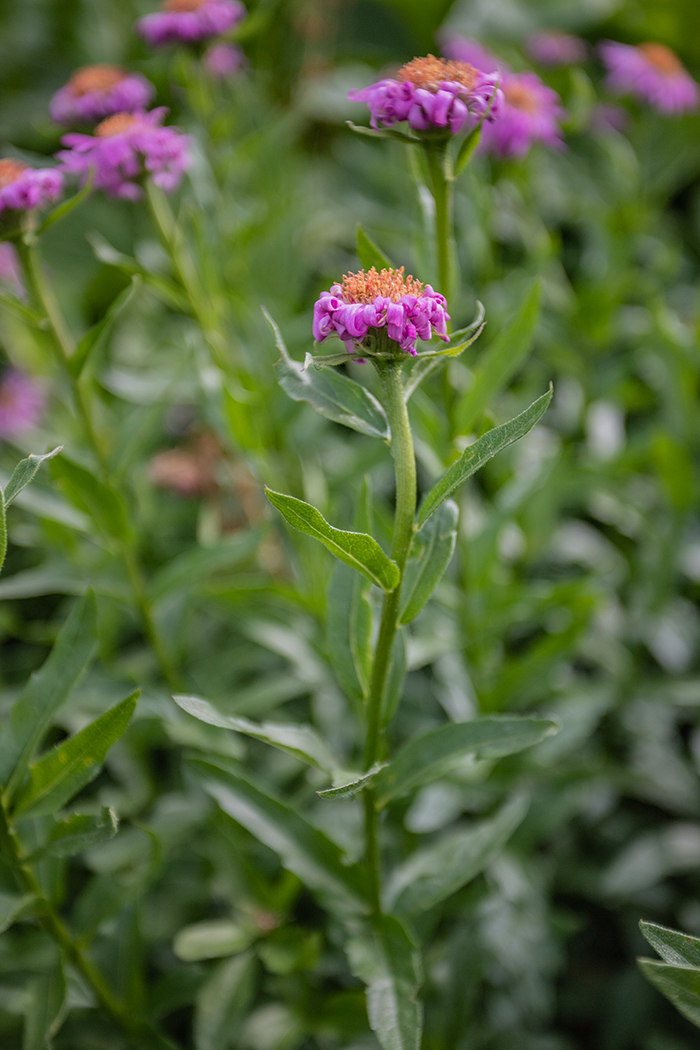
[363,358,416,914]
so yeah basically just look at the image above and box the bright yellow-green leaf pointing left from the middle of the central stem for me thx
[266,487,401,591]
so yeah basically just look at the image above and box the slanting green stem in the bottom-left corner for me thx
[0,802,176,1050]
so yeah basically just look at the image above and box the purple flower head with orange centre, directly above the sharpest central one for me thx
[347,55,500,134]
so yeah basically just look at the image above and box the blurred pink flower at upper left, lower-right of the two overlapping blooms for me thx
[57,106,190,201]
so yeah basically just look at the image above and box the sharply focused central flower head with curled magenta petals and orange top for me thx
[314,267,449,355]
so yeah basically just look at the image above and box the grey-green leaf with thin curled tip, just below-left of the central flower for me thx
[262,310,389,441]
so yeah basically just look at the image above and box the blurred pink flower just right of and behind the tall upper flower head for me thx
[480,72,566,158]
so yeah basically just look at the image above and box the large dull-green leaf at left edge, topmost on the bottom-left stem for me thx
[0,593,98,797]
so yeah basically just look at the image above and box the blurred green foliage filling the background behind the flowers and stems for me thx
[0,0,700,1050]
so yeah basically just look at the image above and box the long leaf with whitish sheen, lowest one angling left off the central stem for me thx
[190,759,368,914]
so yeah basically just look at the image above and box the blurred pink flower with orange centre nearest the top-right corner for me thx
[598,40,700,113]
